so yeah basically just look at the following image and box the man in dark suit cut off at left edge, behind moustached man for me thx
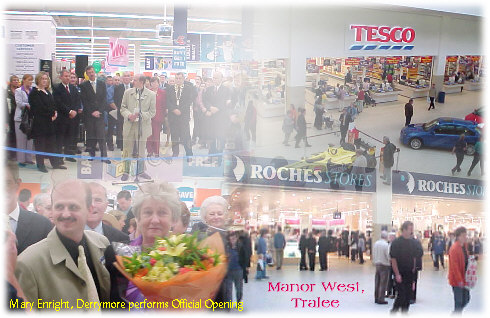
[4,161,53,254]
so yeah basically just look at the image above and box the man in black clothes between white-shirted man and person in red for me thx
[390,221,422,313]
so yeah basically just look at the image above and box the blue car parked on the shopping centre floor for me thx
[400,117,480,155]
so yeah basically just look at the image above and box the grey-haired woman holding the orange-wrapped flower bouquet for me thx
[126,182,181,302]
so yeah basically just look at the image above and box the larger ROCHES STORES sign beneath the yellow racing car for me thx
[225,155,376,192]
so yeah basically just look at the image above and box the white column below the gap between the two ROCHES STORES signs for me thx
[371,183,392,244]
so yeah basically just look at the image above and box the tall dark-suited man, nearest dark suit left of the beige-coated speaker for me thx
[80,65,110,163]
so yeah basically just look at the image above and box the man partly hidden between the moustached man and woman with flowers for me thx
[85,182,129,243]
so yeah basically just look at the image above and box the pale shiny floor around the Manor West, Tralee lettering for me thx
[243,254,484,315]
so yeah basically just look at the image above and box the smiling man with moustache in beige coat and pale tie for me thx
[15,180,111,309]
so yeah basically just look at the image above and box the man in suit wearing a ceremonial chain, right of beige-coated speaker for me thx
[167,72,197,157]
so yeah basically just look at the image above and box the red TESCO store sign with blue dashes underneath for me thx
[346,24,415,51]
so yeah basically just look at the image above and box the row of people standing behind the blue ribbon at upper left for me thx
[6,66,256,175]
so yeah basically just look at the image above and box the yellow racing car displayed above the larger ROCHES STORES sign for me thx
[286,139,377,172]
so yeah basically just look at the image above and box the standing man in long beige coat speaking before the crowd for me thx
[121,75,156,181]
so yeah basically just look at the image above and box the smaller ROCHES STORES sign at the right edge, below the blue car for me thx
[392,171,485,200]
